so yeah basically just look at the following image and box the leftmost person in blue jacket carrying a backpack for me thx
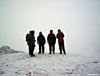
[26,30,35,57]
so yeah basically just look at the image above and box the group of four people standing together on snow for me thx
[26,29,66,57]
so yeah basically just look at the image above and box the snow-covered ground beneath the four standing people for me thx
[0,45,100,76]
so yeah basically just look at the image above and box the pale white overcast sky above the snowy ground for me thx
[0,0,100,51]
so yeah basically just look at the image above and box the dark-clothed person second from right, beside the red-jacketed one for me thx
[47,30,56,54]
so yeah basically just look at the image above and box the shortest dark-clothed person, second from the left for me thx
[37,32,45,54]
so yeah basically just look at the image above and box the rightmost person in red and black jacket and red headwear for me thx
[56,29,66,54]
